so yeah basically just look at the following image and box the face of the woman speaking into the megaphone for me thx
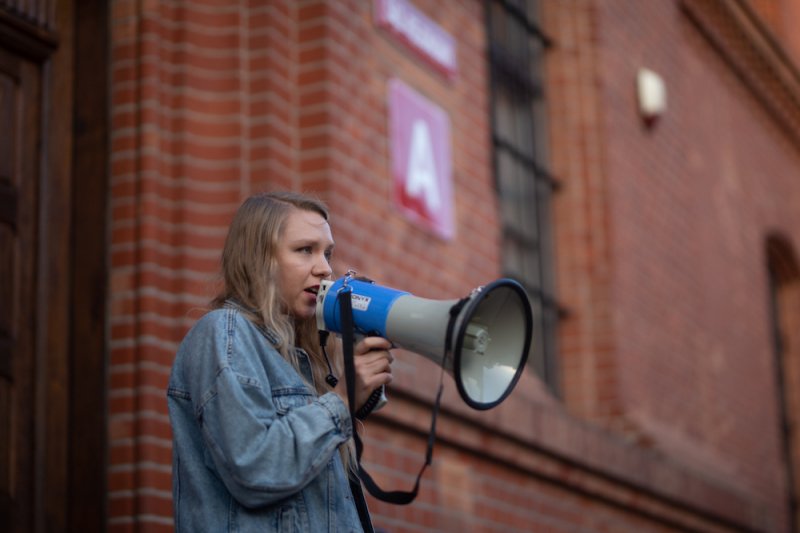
[277,209,333,318]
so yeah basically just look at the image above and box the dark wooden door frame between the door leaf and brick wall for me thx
[0,0,110,531]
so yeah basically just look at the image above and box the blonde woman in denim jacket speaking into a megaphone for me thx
[168,193,392,533]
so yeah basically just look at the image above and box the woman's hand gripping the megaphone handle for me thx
[334,337,394,411]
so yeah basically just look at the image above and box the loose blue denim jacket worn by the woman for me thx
[167,303,362,533]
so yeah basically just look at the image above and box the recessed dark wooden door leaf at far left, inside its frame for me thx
[0,49,41,531]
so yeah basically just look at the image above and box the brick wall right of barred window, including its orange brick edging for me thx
[547,2,800,516]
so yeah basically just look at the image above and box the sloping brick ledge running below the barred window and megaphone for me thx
[376,383,779,531]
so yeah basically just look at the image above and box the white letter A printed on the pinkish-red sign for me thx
[406,119,442,211]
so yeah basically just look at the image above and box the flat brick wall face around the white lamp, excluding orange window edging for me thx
[602,0,800,512]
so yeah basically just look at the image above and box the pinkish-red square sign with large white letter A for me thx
[389,79,455,239]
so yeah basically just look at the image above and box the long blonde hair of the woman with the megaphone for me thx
[211,192,338,394]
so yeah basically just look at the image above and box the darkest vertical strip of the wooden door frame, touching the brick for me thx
[68,0,111,532]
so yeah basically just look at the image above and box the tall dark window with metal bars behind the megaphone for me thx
[487,0,559,393]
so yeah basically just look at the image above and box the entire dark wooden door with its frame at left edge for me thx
[0,0,108,533]
